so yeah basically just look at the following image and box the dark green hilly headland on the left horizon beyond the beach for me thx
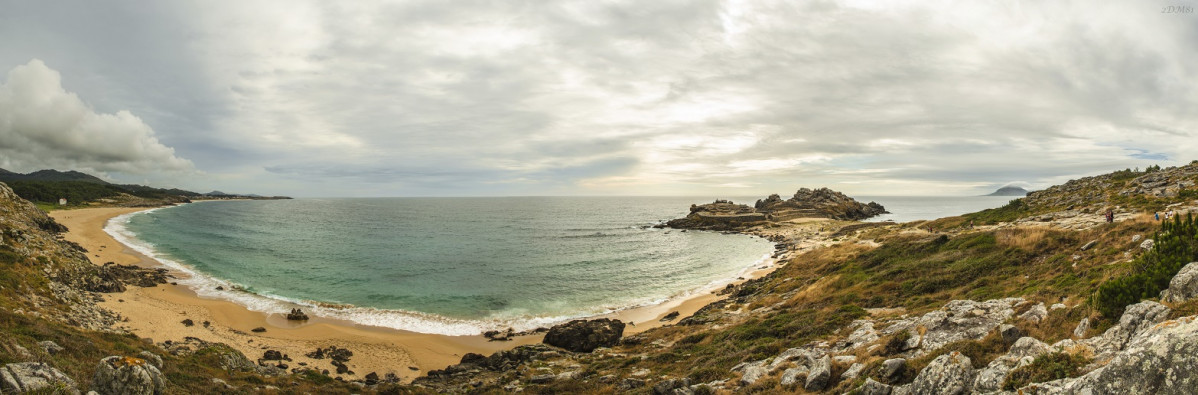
[0,169,291,207]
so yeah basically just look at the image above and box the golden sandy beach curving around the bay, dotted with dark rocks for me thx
[50,207,790,382]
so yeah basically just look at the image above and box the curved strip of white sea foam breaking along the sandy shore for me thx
[104,203,776,336]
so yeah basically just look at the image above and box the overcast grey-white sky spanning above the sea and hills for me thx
[0,0,1198,196]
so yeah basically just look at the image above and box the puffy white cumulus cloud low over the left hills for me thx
[0,59,194,175]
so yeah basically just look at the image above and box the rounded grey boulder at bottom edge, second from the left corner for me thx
[91,356,167,395]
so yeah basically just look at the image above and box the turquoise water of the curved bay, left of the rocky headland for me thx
[109,198,773,335]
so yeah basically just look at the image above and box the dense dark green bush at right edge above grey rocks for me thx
[1090,214,1198,320]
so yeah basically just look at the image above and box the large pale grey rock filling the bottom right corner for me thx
[1019,316,1198,395]
